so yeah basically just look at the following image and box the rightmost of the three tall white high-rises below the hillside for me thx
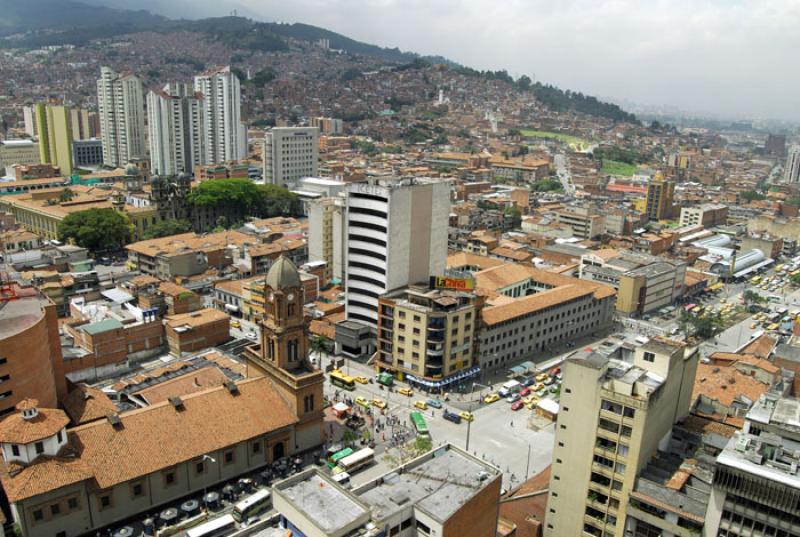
[194,65,247,164]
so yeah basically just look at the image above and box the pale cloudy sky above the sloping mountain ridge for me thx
[90,0,800,121]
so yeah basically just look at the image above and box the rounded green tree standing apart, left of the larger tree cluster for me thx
[58,209,133,252]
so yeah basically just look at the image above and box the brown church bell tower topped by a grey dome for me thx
[245,256,325,451]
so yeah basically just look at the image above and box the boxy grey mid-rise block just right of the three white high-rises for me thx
[263,127,319,186]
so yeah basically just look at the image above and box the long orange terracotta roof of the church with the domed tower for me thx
[0,377,297,502]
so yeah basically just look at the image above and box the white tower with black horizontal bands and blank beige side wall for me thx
[345,178,450,328]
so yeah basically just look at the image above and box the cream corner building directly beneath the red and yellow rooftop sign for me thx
[376,285,479,387]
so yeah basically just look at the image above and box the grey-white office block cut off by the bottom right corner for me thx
[704,393,800,537]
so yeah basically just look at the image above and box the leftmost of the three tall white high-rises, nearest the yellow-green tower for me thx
[97,67,145,167]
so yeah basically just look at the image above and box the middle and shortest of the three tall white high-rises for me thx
[147,83,206,175]
